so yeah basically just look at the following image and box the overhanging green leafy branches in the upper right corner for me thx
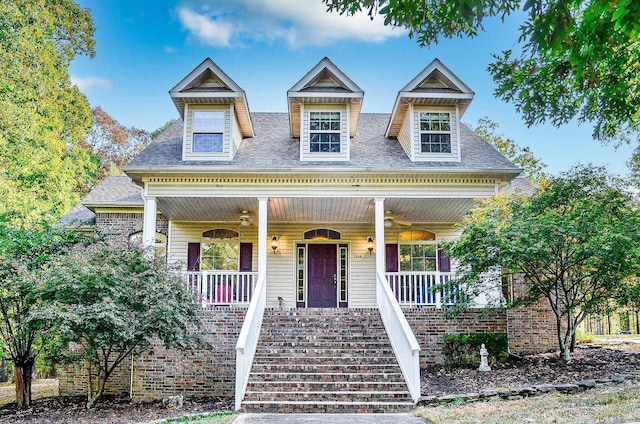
[324,0,640,140]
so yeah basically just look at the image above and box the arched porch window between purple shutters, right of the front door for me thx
[398,230,438,271]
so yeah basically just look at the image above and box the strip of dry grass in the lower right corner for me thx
[415,383,640,424]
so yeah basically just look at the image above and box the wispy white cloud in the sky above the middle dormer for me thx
[178,0,406,48]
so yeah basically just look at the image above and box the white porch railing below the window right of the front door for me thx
[386,271,457,308]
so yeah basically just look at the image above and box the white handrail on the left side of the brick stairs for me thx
[235,272,267,411]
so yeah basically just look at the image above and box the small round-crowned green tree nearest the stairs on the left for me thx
[38,241,200,408]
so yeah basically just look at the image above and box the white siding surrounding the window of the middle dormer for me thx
[300,104,350,161]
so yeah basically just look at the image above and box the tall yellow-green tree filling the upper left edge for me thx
[0,0,99,226]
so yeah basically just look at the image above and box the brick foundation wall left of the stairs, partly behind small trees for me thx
[59,307,246,401]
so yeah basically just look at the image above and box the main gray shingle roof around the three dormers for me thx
[125,113,518,173]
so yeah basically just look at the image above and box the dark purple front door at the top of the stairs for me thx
[307,244,338,308]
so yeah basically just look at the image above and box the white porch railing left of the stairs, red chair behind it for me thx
[185,271,258,307]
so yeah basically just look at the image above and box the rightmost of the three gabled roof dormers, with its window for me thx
[385,59,474,162]
